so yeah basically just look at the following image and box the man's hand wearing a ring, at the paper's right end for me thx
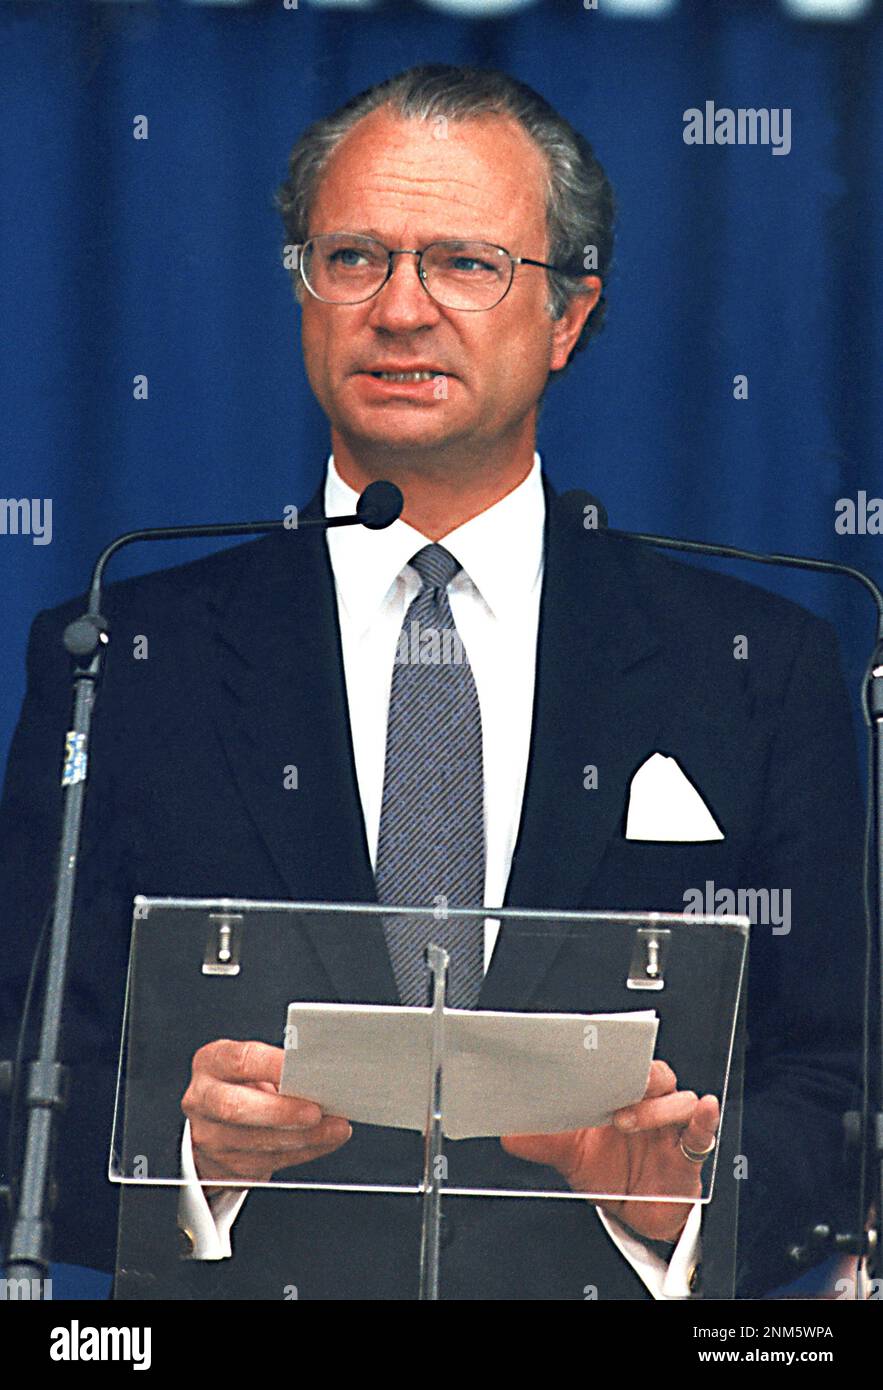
[501,1062,720,1241]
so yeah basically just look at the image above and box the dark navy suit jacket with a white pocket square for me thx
[0,482,862,1298]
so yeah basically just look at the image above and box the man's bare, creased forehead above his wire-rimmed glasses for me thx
[309,108,546,254]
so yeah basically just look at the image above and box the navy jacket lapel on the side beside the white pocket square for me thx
[481,488,661,1009]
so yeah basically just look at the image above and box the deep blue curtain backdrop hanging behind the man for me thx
[0,0,883,1291]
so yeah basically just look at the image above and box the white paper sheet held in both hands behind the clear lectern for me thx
[280,1004,659,1138]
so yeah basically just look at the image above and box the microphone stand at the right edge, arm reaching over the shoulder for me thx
[600,517,883,1272]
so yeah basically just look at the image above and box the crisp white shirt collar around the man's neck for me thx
[324,453,545,631]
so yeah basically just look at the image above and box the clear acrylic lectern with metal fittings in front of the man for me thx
[108,898,748,1300]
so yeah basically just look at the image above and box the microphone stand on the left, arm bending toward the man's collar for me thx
[4,481,403,1297]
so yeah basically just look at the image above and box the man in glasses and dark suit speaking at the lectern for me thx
[4,70,861,1298]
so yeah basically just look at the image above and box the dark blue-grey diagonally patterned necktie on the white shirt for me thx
[374,545,484,1009]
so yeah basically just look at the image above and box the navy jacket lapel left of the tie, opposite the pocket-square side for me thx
[213,489,395,1002]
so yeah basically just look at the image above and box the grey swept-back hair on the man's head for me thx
[275,64,615,364]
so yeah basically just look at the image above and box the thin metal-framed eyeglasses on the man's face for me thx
[293,232,586,313]
